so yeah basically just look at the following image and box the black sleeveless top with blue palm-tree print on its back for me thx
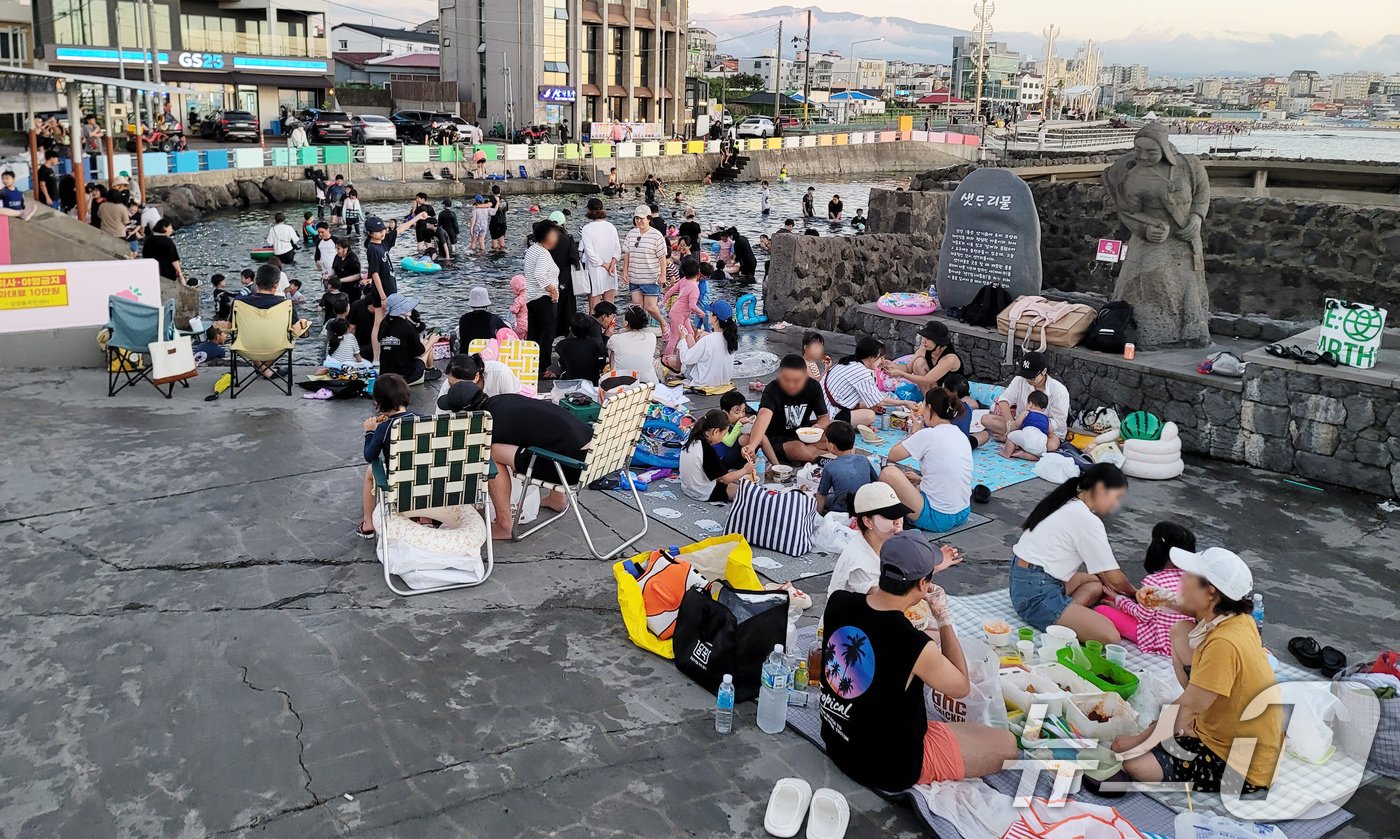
[822,591,930,790]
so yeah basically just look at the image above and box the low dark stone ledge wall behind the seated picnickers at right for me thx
[844,305,1400,497]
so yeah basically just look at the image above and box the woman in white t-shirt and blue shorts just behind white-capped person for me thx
[879,388,972,534]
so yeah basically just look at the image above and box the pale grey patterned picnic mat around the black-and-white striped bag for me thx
[610,478,991,583]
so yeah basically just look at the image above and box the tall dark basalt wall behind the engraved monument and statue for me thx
[766,179,1400,331]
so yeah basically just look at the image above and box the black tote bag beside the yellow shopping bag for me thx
[672,580,788,702]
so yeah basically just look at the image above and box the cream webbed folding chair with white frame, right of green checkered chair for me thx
[511,384,651,559]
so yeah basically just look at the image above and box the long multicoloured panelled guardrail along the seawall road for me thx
[10,130,979,190]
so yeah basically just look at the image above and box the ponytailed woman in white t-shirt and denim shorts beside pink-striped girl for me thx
[1011,464,1137,644]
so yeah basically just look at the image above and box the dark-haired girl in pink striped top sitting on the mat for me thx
[1095,521,1196,657]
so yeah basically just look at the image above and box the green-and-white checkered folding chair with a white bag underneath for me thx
[370,412,496,597]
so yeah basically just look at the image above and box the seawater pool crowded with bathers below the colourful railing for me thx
[175,178,906,340]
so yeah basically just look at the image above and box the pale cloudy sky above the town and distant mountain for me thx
[332,0,1400,76]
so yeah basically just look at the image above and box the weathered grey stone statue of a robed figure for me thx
[1103,123,1211,347]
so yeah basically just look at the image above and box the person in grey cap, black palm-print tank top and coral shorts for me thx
[822,531,1016,791]
